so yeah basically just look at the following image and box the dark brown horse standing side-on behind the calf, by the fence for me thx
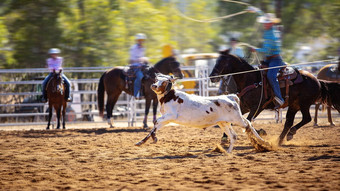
[98,57,183,128]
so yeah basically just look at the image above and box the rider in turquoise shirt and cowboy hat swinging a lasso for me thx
[251,9,286,108]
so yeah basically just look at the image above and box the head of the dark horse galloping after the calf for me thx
[209,49,241,82]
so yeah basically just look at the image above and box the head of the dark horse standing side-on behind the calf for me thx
[155,56,183,78]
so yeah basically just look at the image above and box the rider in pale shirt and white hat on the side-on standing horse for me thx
[130,33,147,99]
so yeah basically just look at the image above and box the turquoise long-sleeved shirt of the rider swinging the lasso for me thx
[256,26,281,57]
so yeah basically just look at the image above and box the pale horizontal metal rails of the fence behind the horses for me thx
[0,62,338,126]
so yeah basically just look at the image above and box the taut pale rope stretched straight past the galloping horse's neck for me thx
[177,59,336,82]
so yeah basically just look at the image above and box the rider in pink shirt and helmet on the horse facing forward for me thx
[42,48,72,102]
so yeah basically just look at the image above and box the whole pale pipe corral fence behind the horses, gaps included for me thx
[0,62,338,127]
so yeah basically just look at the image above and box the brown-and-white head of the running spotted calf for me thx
[151,74,176,94]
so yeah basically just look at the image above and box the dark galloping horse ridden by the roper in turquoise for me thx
[210,50,340,145]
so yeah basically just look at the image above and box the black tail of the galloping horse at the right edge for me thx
[319,80,340,113]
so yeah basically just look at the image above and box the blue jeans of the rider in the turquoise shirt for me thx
[266,57,285,101]
